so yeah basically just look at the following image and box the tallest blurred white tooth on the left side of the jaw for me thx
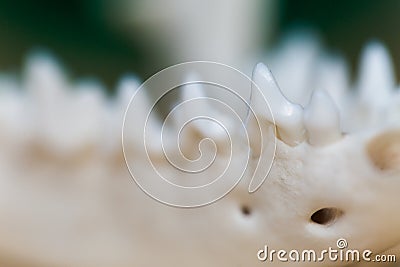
[24,53,72,155]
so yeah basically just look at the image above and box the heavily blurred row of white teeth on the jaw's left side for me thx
[0,54,145,157]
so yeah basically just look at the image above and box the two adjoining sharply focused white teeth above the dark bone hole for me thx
[253,63,341,146]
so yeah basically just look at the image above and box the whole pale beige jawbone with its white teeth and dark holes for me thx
[0,39,400,266]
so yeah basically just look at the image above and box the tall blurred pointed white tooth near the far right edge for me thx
[358,42,395,108]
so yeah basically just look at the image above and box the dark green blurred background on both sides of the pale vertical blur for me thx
[0,0,400,88]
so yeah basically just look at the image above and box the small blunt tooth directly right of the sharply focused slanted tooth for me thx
[304,90,342,146]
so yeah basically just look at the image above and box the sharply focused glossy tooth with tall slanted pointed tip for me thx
[253,63,305,146]
